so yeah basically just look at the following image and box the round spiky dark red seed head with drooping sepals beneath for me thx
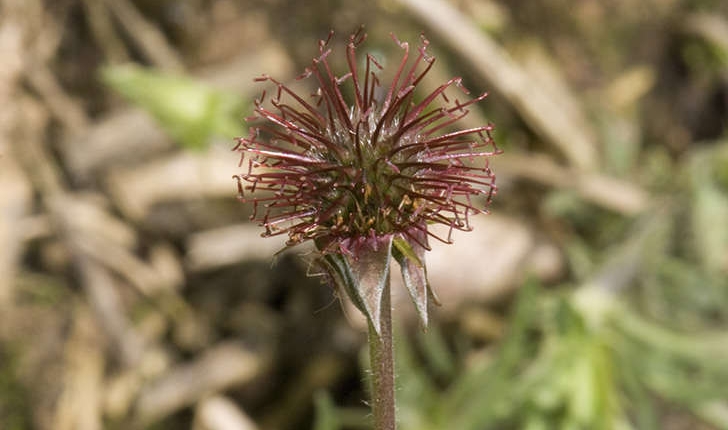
[235,31,500,328]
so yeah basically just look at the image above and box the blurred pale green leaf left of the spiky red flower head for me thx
[101,64,245,150]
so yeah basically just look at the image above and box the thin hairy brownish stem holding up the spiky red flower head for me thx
[369,279,396,430]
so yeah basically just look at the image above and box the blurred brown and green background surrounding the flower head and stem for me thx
[0,0,728,430]
